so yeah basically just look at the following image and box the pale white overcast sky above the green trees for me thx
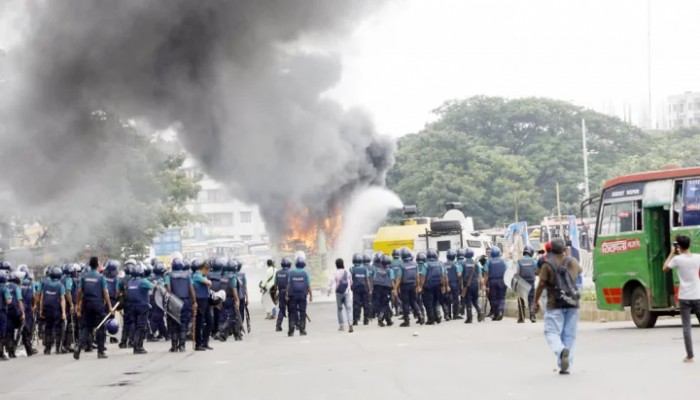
[0,0,700,136]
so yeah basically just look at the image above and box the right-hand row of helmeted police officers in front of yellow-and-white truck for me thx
[312,246,537,331]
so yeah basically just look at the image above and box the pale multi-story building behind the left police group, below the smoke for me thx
[182,159,268,244]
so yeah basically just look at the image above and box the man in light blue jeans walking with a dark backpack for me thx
[535,238,581,375]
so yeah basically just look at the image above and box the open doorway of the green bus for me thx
[644,206,673,308]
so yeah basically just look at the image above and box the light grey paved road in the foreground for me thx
[0,302,700,400]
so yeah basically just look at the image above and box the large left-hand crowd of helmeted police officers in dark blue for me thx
[0,257,258,361]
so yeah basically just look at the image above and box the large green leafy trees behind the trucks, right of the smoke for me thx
[387,96,672,228]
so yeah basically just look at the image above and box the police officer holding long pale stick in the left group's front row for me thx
[73,257,114,360]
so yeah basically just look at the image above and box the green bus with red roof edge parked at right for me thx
[582,167,700,328]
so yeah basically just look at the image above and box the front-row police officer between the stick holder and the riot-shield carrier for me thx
[126,263,155,354]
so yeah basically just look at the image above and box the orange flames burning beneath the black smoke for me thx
[281,208,342,253]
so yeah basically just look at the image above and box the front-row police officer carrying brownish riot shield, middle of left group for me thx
[165,258,197,353]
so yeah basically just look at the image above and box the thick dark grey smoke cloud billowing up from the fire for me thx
[0,0,394,247]
